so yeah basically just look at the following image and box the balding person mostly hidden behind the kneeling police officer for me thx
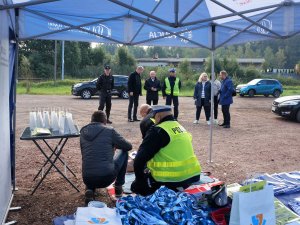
[140,104,155,139]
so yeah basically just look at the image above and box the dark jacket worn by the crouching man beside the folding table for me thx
[80,123,132,177]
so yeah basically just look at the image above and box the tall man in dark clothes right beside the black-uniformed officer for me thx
[128,66,144,122]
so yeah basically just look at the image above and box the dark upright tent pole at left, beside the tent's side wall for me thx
[12,8,19,191]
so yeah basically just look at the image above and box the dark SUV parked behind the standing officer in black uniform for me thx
[71,75,129,99]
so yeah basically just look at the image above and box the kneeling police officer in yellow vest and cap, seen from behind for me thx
[131,105,201,195]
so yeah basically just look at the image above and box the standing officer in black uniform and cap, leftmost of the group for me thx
[96,65,114,124]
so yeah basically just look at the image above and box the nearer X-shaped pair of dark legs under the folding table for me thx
[31,138,80,195]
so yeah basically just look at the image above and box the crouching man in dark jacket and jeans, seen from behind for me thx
[80,110,132,204]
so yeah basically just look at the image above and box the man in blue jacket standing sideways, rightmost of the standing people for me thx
[219,70,234,128]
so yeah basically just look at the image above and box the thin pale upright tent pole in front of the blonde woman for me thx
[208,24,216,163]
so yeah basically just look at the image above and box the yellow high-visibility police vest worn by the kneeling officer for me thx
[147,121,201,182]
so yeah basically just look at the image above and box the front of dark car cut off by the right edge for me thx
[272,95,300,123]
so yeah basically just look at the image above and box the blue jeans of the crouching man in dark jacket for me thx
[83,150,128,191]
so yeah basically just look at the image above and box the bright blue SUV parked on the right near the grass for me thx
[236,79,283,98]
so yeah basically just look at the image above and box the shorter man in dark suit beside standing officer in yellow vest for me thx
[144,71,161,105]
